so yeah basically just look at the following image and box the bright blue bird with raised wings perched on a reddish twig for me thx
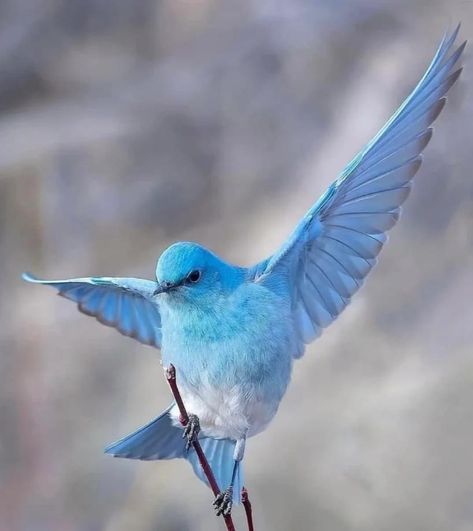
[23,25,466,515]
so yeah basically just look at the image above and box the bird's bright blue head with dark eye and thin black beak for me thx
[154,242,243,304]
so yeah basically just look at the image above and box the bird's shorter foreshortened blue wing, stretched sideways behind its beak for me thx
[23,273,161,348]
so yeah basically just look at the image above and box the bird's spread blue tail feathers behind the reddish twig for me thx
[105,404,243,503]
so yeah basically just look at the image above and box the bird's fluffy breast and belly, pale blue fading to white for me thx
[162,285,293,438]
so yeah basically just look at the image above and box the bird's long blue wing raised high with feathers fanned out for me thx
[253,27,466,355]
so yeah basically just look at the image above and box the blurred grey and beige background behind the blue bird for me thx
[0,0,473,531]
